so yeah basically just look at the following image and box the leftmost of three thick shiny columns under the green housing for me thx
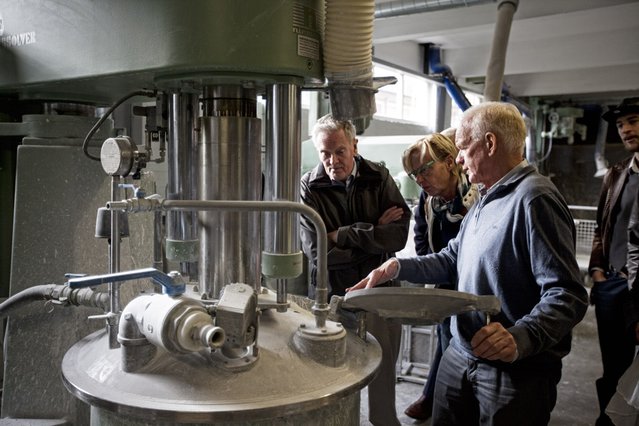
[166,92,199,278]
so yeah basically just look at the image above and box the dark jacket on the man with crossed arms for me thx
[300,157,411,298]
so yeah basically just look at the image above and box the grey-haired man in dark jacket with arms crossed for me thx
[301,115,410,426]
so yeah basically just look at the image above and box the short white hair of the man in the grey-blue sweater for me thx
[461,102,527,156]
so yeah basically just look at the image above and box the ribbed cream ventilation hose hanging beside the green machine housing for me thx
[323,0,375,119]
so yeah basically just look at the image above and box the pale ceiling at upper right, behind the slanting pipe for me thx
[373,0,639,101]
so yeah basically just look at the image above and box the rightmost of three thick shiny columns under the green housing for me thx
[264,84,302,304]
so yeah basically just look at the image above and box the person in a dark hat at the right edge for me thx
[588,98,639,426]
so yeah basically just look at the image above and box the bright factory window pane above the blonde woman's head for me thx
[373,64,437,128]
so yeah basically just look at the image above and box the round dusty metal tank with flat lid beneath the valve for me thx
[62,298,381,426]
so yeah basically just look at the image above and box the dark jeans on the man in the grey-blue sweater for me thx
[432,345,561,426]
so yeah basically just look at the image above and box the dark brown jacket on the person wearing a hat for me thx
[588,157,633,274]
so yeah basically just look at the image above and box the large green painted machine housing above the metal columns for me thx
[0,0,324,103]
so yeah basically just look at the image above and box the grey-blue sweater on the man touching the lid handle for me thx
[398,165,588,367]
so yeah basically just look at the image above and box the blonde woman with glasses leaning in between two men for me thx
[402,129,479,420]
